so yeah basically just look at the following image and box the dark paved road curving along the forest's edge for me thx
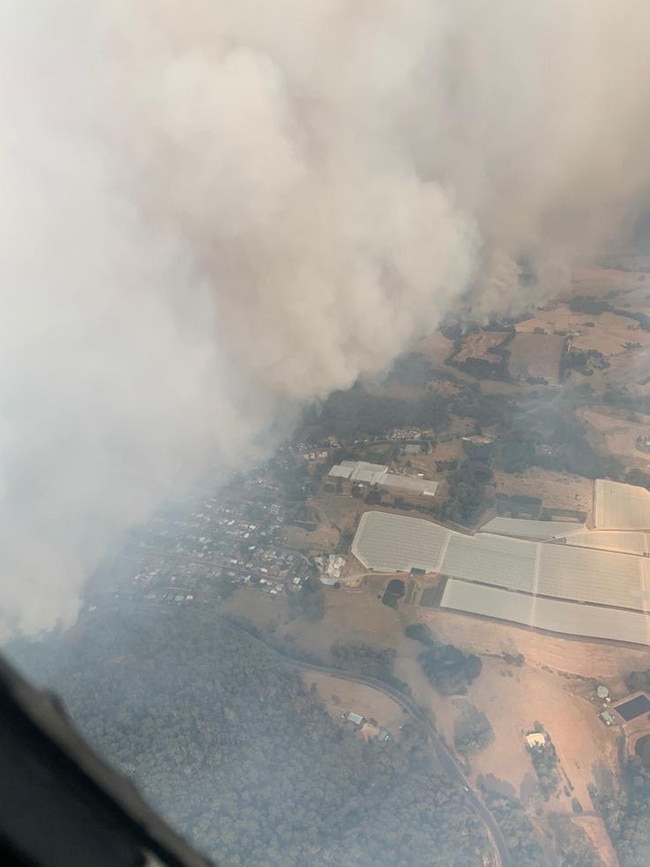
[217,614,512,867]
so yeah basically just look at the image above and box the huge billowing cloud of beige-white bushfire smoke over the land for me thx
[0,0,650,639]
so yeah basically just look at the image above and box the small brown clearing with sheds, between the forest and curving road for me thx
[302,671,408,738]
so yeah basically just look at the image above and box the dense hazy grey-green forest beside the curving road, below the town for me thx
[13,609,487,867]
